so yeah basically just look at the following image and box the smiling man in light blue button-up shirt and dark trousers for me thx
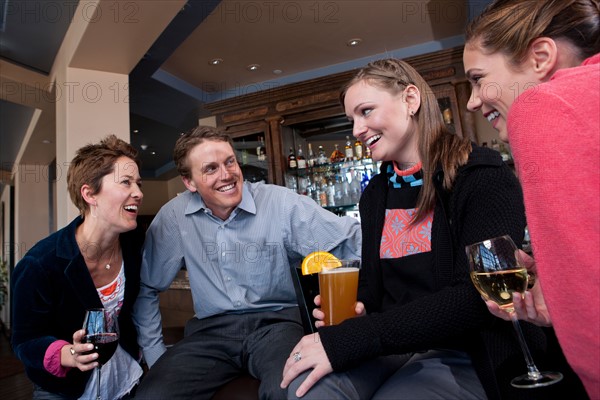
[134,126,361,399]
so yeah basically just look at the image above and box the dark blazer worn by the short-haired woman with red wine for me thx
[11,217,143,397]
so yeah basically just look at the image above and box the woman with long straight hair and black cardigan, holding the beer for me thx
[282,59,576,400]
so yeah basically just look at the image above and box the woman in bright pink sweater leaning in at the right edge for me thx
[463,0,600,399]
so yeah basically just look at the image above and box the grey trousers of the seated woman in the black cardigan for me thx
[288,350,487,400]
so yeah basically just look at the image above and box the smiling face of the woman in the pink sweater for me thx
[463,44,541,142]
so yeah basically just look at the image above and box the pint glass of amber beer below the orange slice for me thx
[319,260,360,325]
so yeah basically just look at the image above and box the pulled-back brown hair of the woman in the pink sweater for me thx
[465,0,600,66]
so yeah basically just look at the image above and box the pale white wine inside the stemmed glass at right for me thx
[471,268,527,312]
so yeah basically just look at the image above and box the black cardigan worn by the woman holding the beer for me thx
[319,146,576,399]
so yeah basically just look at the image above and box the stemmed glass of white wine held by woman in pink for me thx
[465,235,563,388]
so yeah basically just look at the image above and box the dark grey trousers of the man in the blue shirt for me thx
[135,307,304,400]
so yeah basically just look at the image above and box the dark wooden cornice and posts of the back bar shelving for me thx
[205,46,477,179]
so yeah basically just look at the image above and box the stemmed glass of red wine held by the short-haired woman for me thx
[83,308,119,400]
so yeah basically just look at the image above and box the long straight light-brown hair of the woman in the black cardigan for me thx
[340,58,472,222]
